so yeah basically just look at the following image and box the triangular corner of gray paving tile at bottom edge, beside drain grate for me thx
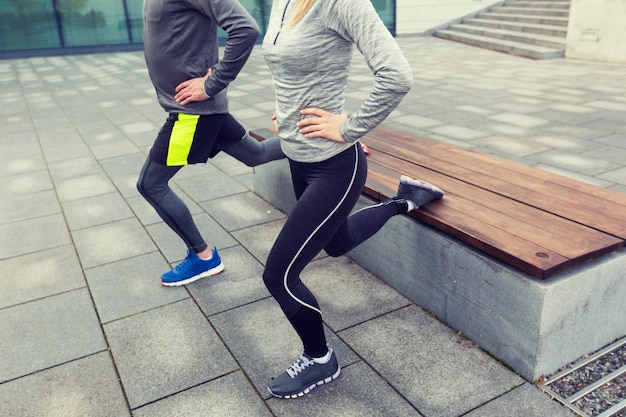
[464,383,576,417]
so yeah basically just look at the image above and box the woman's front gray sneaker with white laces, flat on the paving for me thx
[267,349,341,398]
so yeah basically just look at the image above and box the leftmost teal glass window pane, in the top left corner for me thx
[0,0,60,51]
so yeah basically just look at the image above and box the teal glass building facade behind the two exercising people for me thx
[0,0,396,58]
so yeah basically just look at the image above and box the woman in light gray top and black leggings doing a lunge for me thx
[263,0,443,398]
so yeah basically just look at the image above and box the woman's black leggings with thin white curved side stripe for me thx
[263,143,399,357]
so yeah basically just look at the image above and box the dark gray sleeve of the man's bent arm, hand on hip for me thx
[197,0,259,97]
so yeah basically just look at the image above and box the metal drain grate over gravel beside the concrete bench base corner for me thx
[537,339,626,417]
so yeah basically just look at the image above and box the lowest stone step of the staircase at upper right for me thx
[434,30,564,59]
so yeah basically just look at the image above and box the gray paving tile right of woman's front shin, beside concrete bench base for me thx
[302,256,411,332]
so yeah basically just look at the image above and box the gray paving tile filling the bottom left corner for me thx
[0,352,130,417]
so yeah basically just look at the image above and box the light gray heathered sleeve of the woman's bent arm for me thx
[327,0,413,142]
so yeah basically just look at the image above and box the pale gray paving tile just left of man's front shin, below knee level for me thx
[63,193,133,230]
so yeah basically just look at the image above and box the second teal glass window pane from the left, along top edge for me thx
[56,0,129,46]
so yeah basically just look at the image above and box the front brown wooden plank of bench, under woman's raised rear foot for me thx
[367,157,623,279]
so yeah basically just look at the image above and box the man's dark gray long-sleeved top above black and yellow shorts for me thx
[143,0,259,114]
